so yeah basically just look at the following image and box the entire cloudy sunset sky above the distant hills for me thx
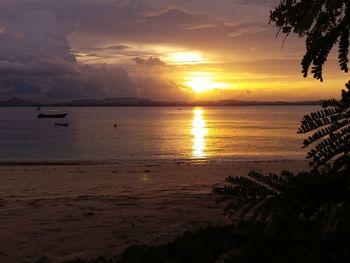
[0,0,349,101]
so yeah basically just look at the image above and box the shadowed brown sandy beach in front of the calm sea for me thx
[0,161,307,263]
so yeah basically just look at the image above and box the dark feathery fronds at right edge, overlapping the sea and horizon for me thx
[298,81,350,170]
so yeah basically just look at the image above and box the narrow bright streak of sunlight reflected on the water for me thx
[192,109,208,158]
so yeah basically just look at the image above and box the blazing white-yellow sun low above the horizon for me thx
[185,72,228,93]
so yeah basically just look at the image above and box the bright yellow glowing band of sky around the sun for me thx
[76,41,347,101]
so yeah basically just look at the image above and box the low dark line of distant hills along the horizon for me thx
[0,97,323,107]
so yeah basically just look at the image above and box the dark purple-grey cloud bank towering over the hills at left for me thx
[0,8,136,99]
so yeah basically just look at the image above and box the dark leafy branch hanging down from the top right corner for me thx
[270,0,350,81]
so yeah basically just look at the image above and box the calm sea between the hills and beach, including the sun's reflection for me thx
[0,106,318,161]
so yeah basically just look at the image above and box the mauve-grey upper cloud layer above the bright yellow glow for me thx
[0,0,284,58]
